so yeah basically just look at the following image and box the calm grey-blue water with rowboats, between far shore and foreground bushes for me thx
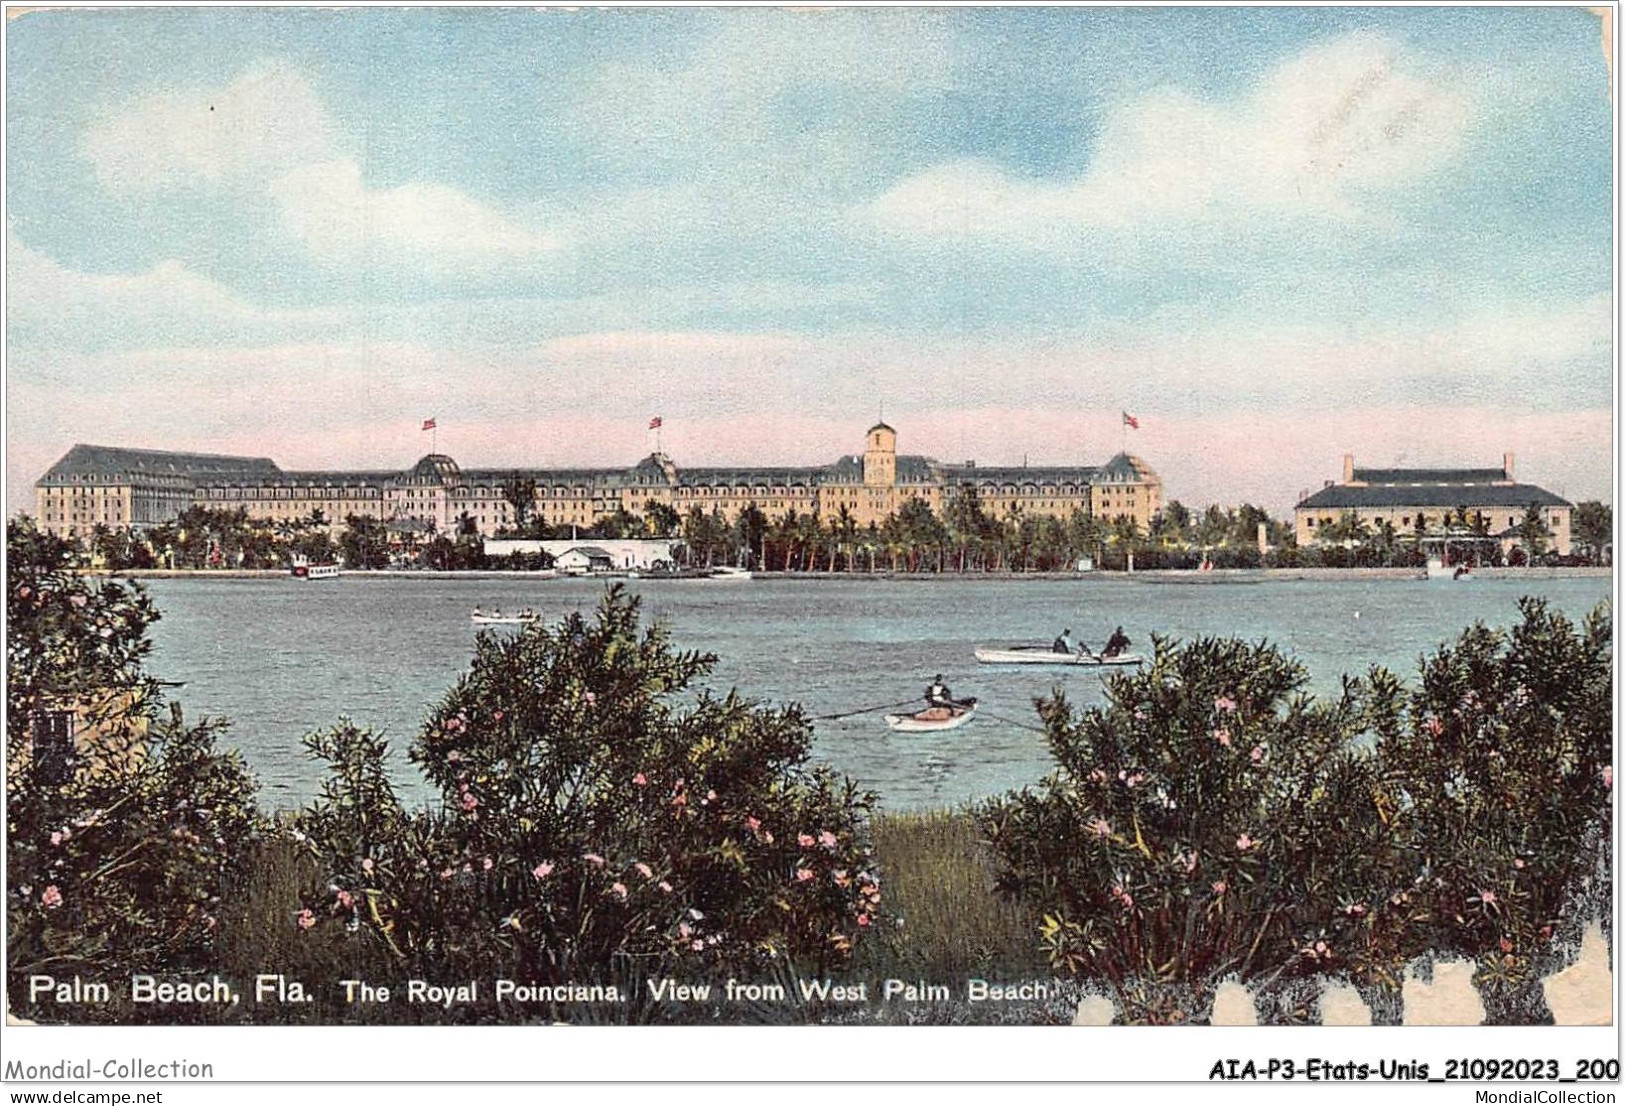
[148,577,1610,809]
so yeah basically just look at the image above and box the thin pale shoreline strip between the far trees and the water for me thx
[92,565,1614,585]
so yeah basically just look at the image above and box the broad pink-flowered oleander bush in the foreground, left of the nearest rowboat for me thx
[299,590,881,1006]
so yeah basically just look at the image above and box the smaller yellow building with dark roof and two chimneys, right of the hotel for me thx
[1295,453,1575,555]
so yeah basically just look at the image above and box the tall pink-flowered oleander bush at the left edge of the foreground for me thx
[7,520,257,1017]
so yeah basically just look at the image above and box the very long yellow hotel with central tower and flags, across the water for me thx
[34,422,1162,536]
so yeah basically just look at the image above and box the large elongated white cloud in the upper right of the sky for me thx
[866,34,1469,247]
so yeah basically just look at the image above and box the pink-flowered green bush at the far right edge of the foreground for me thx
[1376,599,1614,1004]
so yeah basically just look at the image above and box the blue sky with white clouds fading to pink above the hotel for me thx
[5,6,1614,513]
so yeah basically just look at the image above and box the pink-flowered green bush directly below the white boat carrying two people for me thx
[980,638,1386,1020]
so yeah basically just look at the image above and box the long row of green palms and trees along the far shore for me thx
[34,487,1614,573]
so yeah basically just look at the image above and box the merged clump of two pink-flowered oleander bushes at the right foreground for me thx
[978,599,1612,1022]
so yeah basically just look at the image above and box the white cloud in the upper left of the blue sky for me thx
[83,63,562,273]
